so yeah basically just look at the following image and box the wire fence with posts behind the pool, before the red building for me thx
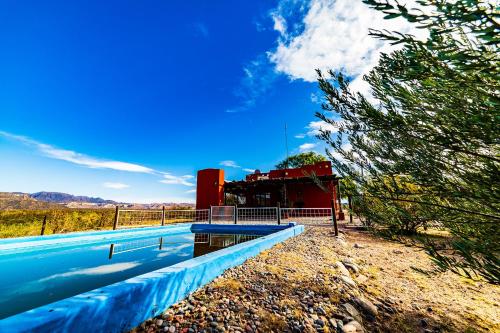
[114,206,334,229]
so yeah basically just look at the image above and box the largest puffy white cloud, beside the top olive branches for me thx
[269,0,425,87]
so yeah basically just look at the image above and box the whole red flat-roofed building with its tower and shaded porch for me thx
[196,161,344,220]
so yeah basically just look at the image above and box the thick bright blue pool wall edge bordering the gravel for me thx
[0,224,304,333]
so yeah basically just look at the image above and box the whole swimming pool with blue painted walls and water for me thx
[0,224,303,332]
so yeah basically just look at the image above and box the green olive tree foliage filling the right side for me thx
[317,0,500,283]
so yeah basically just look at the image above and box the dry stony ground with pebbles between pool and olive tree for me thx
[133,227,500,333]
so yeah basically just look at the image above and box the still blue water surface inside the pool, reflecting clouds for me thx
[0,226,259,319]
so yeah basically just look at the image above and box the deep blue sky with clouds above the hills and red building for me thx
[0,0,414,202]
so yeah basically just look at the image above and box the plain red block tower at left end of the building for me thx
[196,169,224,209]
